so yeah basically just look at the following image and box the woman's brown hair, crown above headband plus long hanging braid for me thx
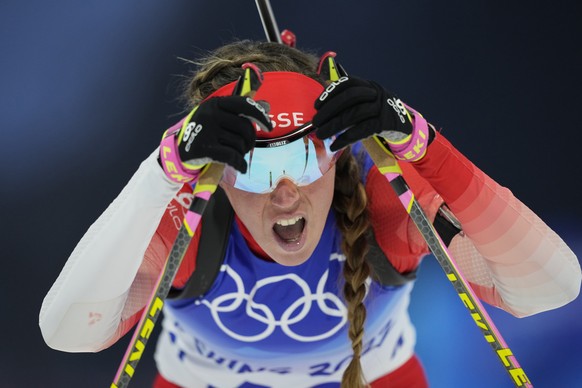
[185,41,370,388]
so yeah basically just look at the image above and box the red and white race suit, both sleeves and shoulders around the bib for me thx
[39,134,581,386]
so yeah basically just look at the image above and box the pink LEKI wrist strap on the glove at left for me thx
[160,120,200,183]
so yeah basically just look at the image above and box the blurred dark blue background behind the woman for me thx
[0,0,582,387]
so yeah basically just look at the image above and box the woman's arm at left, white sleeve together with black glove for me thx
[39,96,271,352]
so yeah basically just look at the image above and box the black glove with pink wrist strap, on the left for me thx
[160,96,272,183]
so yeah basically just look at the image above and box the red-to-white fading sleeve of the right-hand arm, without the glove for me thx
[413,134,581,317]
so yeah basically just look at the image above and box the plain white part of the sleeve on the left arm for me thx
[39,150,182,352]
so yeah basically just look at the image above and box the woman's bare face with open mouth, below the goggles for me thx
[221,166,335,266]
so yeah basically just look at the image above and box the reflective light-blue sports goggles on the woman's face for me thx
[223,123,340,194]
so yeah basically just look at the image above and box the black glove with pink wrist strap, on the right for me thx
[313,77,433,162]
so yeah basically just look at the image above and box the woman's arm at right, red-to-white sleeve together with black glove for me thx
[313,77,581,316]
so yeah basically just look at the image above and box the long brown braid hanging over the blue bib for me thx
[332,149,370,388]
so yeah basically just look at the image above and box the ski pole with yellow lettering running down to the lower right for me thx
[257,0,533,388]
